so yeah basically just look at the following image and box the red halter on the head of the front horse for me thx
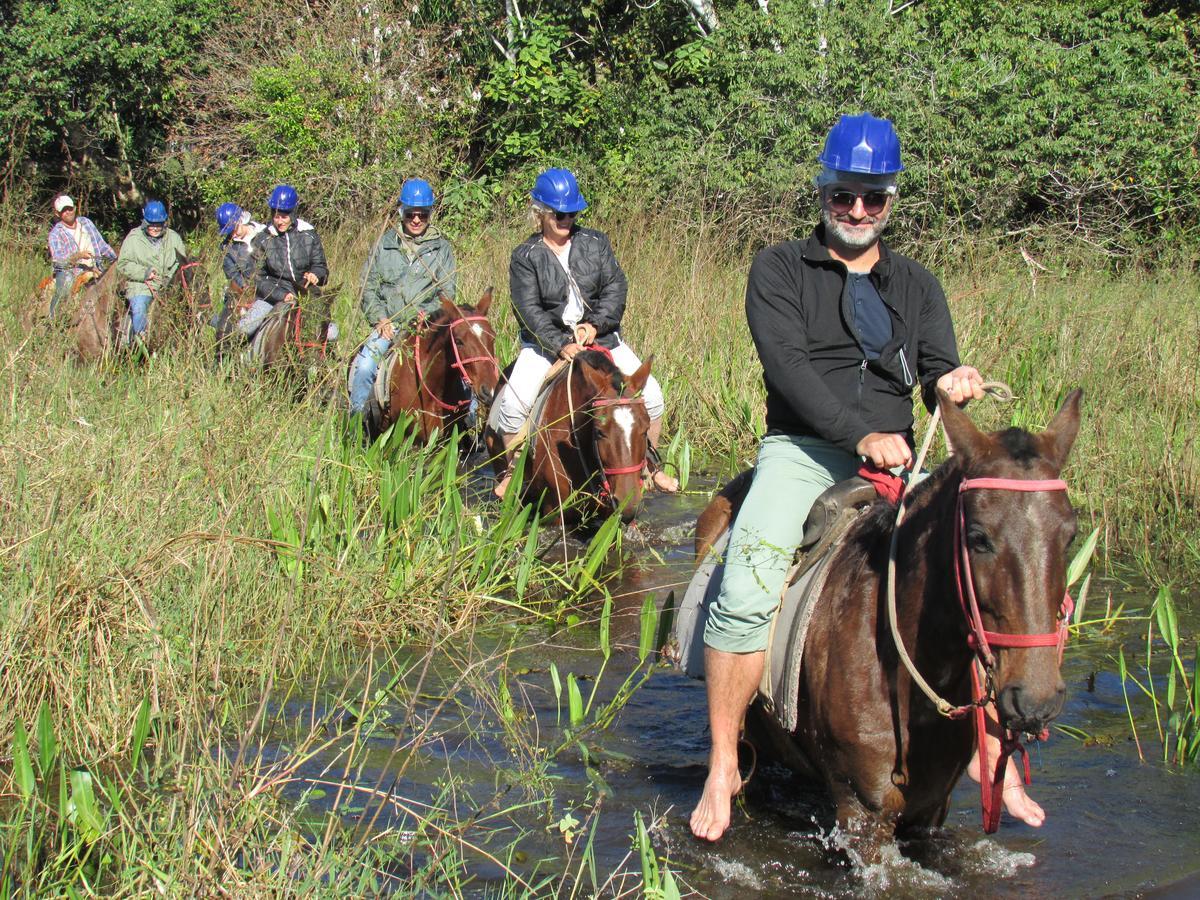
[954,478,1075,834]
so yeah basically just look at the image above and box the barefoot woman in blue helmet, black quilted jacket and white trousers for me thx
[491,169,679,497]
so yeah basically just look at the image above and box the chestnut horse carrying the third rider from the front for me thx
[362,288,500,440]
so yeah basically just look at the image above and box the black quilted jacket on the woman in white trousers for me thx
[509,226,628,355]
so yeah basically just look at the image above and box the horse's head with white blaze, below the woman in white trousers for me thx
[576,353,653,522]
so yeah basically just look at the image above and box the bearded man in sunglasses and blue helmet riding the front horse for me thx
[691,113,1044,840]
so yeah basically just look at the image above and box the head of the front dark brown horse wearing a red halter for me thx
[938,390,1082,734]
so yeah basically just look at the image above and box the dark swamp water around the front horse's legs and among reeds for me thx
[260,482,1200,900]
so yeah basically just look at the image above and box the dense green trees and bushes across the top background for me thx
[0,0,1200,251]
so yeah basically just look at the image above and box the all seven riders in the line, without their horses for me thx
[50,113,1044,840]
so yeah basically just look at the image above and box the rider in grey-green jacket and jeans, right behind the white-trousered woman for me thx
[350,178,456,413]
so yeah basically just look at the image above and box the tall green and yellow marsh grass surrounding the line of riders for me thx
[0,215,1200,895]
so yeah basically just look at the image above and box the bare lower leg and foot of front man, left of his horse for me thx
[691,647,766,841]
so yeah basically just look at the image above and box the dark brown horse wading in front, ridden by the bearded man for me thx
[697,390,1081,851]
